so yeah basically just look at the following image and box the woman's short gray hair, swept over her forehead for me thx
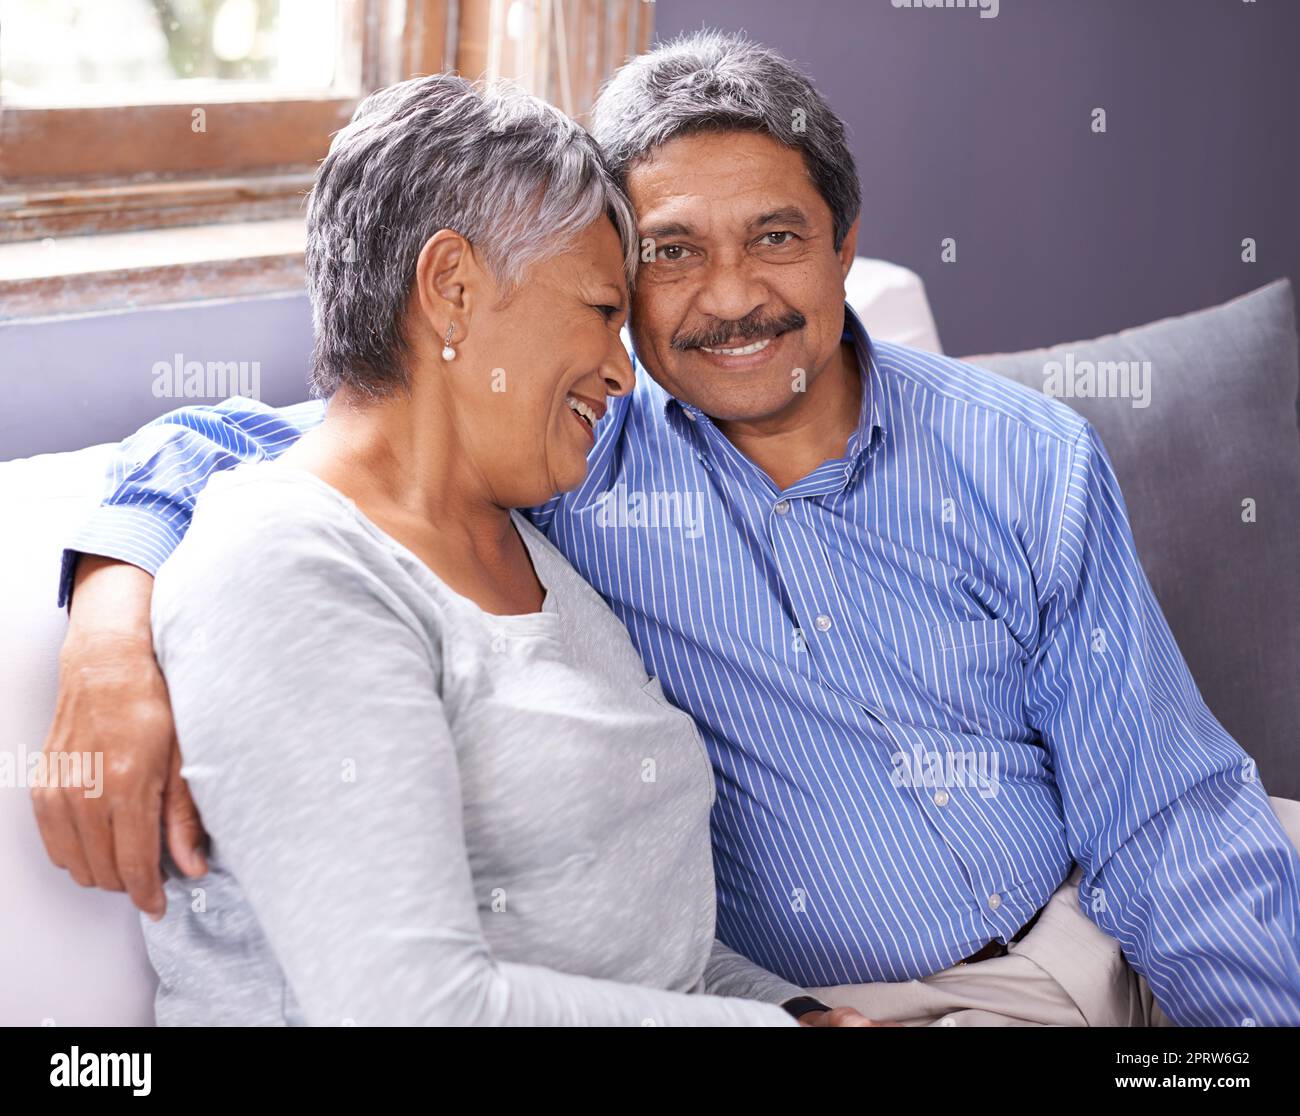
[307,74,637,397]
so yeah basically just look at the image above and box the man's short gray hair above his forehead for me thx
[592,31,862,251]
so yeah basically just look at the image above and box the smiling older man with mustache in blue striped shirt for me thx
[38,34,1300,1025]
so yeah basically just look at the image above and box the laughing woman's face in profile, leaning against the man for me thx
[457,220,634,507]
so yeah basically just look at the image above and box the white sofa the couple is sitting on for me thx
[0,259,940,1026]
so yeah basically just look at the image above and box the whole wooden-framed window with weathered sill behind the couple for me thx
[0,0,653,319]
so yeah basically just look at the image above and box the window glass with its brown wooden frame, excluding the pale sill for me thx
[0,0,423,241]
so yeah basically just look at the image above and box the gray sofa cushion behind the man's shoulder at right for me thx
[966,280,1300,799]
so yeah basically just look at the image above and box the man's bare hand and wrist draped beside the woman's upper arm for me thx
[33,555,208,918]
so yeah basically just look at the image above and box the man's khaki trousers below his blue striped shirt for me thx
[809,799,1300,1026]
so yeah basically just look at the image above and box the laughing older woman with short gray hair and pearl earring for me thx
[144,75,800,1026]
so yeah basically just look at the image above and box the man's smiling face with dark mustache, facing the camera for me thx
[628,131,857,421]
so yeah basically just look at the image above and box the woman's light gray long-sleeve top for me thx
[149,463,801,1026]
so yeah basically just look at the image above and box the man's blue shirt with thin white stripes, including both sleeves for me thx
[61,310,1300,1025]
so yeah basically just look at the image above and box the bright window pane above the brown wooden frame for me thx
[0,0,347,107]
